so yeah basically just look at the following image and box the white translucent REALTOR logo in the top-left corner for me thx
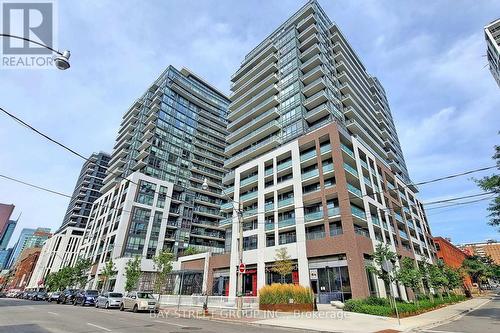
[0,0,57,69]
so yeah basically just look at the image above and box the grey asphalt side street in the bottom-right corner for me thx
[420,294,500,333]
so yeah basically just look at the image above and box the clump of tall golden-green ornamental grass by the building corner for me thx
[259,283,314,304]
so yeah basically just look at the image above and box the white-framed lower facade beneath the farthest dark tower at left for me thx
[28,226,84,288]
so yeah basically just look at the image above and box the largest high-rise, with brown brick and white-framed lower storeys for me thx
[218,0,435,303]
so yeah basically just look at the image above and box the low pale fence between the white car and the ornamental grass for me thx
[160,295,259,309]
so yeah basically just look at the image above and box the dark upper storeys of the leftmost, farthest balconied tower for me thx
[60,152,110,229]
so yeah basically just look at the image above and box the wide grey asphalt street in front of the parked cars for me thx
[0,298,292,333]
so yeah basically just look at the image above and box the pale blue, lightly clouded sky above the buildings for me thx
[0,0,500,244]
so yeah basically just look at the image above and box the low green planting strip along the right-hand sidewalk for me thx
[344,295,466,317]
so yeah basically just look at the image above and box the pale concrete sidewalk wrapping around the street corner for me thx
[160,297,489,333]
